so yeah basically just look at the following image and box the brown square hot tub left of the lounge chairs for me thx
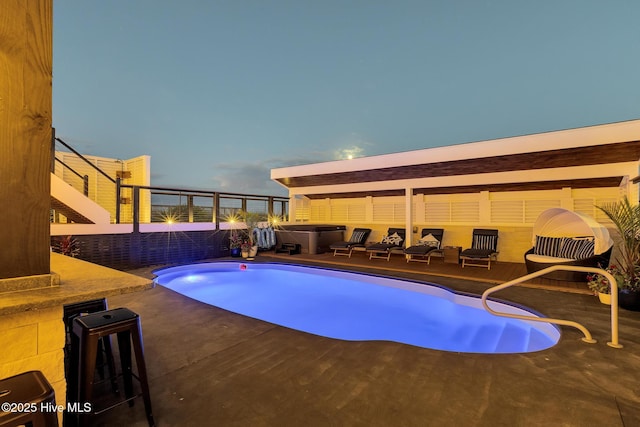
[276,224,347,255]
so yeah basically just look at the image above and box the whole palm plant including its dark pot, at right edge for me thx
[597,197,640,311]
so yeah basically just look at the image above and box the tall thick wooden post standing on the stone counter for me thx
[0,0,53,279]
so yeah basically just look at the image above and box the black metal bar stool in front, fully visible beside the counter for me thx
[71,308,155,426]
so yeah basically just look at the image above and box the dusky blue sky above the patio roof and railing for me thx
[53,0,640,195]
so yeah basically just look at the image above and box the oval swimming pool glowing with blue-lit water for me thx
[154,262,560,353]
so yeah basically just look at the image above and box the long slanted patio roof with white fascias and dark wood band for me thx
[271,120,640,199]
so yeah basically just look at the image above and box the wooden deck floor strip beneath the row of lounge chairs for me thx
[265,251,591,294]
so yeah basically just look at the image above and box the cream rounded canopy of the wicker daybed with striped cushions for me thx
[532,208,613,255]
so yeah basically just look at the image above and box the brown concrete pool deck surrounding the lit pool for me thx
[94,256,640,427]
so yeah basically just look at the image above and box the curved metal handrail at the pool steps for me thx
[482,265,623,348]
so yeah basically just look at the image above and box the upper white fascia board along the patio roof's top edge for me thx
[271,120,640,179]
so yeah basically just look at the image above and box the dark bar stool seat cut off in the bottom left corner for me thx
[0,371,58,427]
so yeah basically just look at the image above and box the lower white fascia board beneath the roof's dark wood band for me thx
[289,162,638,196]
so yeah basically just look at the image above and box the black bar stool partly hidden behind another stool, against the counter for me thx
[62,298,118,400]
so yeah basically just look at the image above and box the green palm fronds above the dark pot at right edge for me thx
[596,197,640,289]
